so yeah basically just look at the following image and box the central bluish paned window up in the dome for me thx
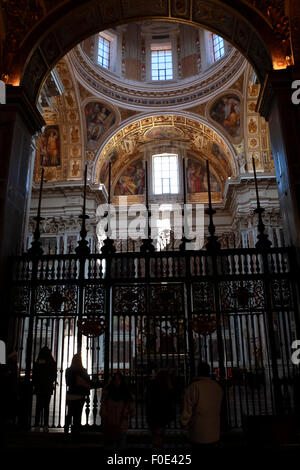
[151,44,173,80]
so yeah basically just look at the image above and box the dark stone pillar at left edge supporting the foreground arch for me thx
[0,86,45,335]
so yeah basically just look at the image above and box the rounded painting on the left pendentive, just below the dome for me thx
[84,101,116,148]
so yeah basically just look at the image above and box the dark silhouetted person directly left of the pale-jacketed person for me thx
[146,370,175,449]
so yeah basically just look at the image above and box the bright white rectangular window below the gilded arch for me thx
[152,153,179,194]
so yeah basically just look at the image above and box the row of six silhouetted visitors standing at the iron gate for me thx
[0,346,223,451]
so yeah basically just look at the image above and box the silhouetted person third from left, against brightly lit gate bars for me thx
[64,354,91,439]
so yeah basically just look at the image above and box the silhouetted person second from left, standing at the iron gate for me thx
[32,346,57,431]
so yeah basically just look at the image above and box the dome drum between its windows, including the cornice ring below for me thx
[69,22,247,109]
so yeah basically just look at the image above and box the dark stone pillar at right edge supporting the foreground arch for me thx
[258,67,300,250]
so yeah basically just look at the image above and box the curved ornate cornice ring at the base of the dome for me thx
[69,47,246,109]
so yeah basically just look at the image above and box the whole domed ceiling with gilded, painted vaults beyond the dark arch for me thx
[34,22,274,201]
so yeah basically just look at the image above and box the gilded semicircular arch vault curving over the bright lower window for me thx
[96,115,236,190]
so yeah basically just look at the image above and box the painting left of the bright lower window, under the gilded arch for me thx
[115,160,145,196]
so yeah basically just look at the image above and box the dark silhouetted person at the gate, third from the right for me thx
[100,372,135,448]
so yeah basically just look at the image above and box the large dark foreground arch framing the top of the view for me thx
[2,0,287,101]
